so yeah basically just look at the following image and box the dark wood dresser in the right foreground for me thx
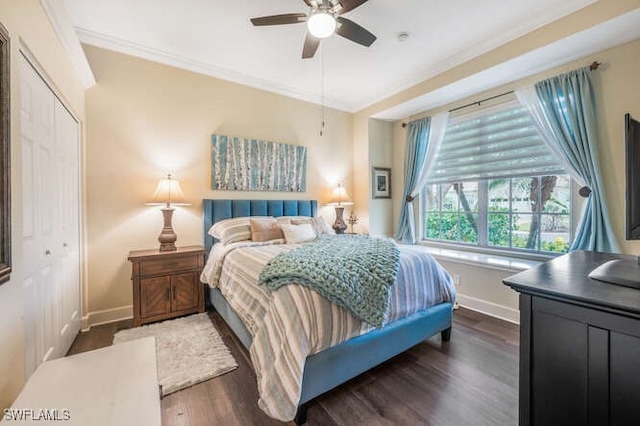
[504,251,640,426]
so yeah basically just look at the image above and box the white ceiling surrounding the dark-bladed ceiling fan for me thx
[64,0,640,119]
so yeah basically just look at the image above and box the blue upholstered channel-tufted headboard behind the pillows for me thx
[202,199,318,253]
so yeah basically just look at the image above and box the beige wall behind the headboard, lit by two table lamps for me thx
[85,46,353,323]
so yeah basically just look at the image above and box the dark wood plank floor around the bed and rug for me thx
[68,309,518,426]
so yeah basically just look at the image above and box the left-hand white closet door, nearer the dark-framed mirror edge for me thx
[20,60,57,375]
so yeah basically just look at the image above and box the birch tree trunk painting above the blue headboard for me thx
[211,135,307,192]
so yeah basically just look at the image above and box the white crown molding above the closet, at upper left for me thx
[40,0,96,89]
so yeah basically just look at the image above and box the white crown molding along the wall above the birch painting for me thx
[76,27,354,112]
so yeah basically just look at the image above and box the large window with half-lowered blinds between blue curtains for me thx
[421,101,573,253]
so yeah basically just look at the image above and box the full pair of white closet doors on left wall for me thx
[20,57,80,376]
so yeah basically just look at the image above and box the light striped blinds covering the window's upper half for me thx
[427,100,566,184]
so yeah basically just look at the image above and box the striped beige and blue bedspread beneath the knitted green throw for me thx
[202,241,455,421]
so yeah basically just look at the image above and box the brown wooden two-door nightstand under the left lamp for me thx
[128,246,204,327]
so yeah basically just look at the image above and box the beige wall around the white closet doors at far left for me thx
[0,0,84,410]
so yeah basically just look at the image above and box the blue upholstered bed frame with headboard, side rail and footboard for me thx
[203,199,455,424]
